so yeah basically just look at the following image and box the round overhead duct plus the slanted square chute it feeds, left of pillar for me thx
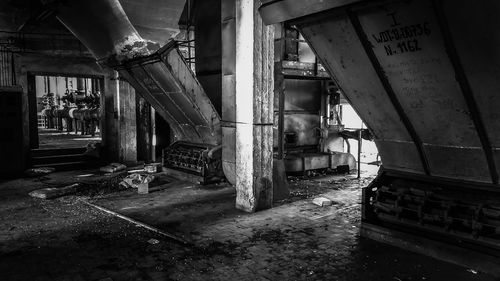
[46,0,227,178]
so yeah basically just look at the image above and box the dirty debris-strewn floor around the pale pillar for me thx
[0,166,499,281]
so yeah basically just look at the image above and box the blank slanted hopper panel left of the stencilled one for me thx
[298,10,423,173]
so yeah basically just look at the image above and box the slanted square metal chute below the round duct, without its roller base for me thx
[118,41,221,145]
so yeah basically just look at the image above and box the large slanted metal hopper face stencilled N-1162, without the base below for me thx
[265,0,500,183]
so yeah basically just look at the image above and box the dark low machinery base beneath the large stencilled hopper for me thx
[363,172,500,250]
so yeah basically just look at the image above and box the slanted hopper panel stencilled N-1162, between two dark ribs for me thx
[357,1,491,181]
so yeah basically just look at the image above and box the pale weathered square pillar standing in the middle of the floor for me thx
[222,0,274,212]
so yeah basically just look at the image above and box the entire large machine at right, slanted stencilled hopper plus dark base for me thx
[260,0,500,273]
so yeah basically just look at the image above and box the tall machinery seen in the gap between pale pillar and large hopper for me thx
[274,23,357,173]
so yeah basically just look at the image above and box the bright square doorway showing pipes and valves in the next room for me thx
[28,74,104,149]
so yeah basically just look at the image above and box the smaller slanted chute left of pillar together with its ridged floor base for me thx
[118,41,224,184]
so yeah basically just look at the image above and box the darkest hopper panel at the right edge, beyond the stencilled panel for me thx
[442,0,500,179]
